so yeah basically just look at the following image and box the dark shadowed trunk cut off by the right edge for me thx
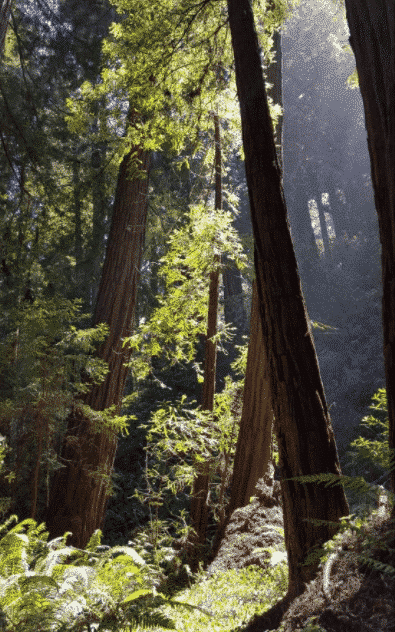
[345,0,395,518]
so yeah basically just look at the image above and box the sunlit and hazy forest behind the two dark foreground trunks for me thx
[0,0,390,630]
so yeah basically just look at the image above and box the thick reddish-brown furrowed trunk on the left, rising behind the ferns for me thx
[46,119,149,547]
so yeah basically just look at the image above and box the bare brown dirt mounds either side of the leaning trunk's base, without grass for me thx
[207,479,395,632]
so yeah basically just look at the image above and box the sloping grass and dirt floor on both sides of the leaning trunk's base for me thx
[143,483,395,632]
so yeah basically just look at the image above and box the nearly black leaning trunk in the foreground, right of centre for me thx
[228,0,349,600]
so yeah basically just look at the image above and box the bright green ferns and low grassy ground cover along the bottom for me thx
[0,516,287,632]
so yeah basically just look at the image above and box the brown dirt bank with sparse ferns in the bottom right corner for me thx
[246,502,395,632]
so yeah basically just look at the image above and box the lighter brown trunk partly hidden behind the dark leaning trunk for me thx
[213,280,273,557]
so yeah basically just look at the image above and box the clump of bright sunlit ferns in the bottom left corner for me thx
[0,516,210,632]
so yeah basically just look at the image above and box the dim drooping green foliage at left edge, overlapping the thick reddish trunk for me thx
[0,297,134,515]
